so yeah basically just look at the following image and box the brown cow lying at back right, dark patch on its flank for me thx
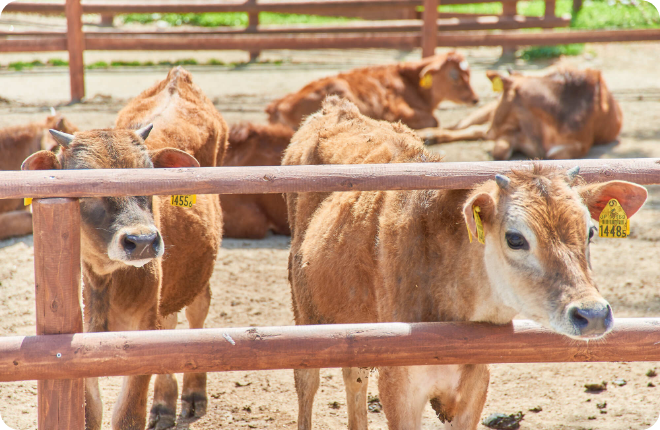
[420,67,622,160]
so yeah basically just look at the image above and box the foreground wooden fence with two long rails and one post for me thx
[0,158,660,429]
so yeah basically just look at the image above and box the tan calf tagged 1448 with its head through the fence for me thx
[282,98,647,430]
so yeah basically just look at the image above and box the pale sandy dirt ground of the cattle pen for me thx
[0,37,660,430]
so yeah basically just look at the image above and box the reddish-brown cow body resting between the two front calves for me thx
[220,123,293,239]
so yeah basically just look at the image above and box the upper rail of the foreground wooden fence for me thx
[0,158,660,199]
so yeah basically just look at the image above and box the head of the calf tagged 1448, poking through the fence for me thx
[464,166,647,340]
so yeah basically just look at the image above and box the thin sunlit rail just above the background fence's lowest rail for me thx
[0,15,571,37]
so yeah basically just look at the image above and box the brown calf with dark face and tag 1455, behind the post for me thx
[23,68,227,430]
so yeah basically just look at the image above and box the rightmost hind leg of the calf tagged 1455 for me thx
[181,285,211,418]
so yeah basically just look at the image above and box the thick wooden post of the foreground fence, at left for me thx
[32,198,85,430]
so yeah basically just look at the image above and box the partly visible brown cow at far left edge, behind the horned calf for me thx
[0,111,78,240]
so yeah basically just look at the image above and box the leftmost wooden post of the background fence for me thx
[65,0,85,103]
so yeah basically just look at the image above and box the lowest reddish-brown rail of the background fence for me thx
[0,29,660,52]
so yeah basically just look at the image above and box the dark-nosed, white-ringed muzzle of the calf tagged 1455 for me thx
[108,227,164,267]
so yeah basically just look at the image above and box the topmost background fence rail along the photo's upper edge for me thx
[2,0,517,14]
